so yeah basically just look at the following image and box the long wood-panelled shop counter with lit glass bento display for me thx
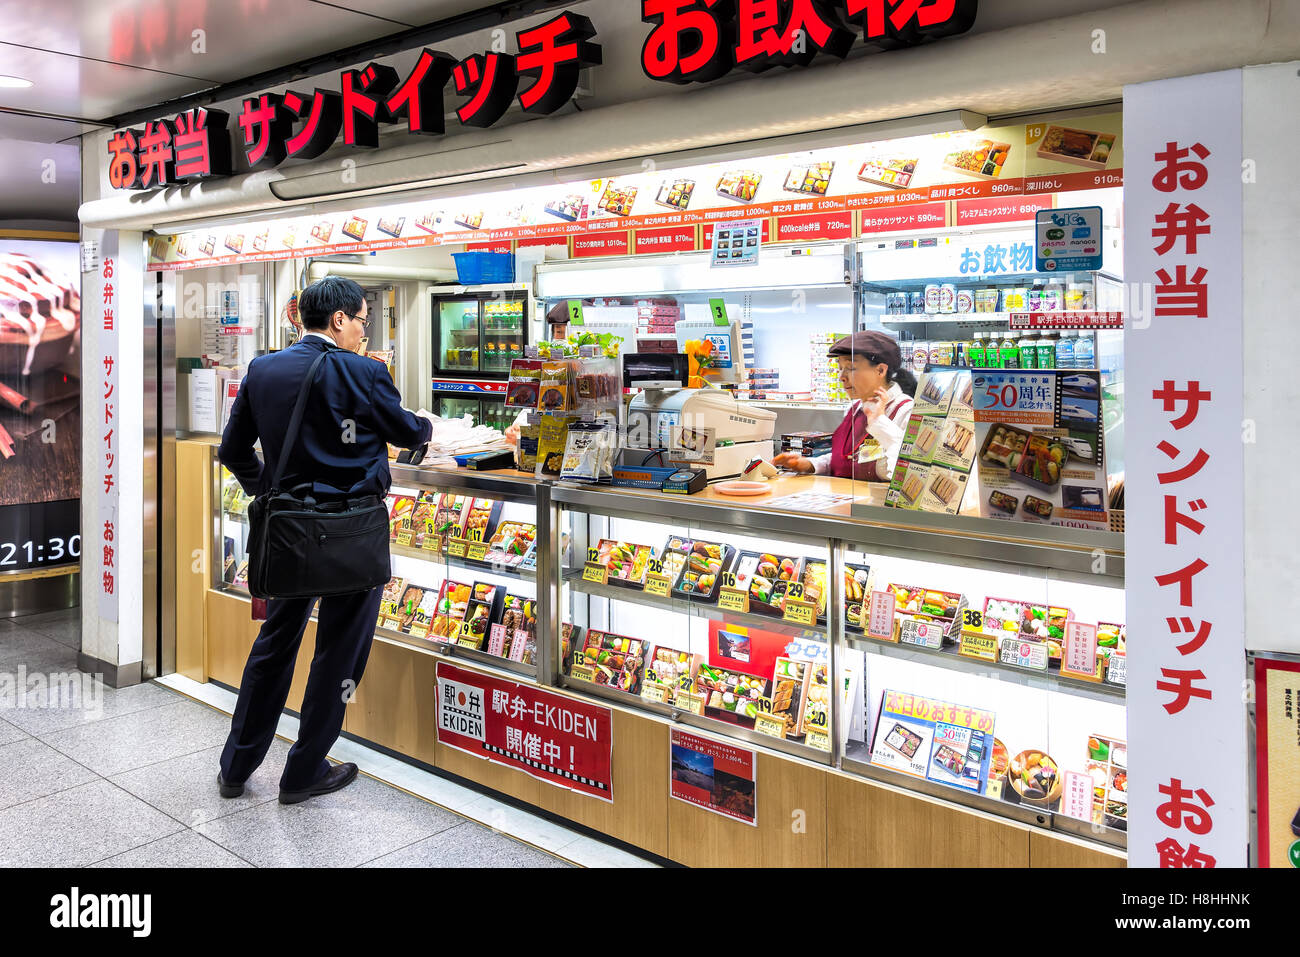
[177,439,1127,867]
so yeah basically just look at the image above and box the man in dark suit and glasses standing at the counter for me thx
[217,276,433,804]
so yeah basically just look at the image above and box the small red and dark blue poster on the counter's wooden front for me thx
[668,728,758,826]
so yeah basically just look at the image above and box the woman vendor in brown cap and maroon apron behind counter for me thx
[774,332,917,482]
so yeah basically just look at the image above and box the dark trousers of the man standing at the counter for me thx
[221,586,384,791]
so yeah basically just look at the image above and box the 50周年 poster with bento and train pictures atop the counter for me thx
[971,369,1109,529]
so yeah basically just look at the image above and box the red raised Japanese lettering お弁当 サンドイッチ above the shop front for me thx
[108,12,602,190]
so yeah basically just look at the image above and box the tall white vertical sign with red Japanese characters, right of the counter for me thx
[1125,70,1251,867]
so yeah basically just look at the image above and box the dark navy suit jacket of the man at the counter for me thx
[217,335,433,497]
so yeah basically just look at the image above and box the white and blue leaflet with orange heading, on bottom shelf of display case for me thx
[871,690,995,793]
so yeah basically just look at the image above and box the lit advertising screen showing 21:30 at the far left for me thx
[0,239,82,573]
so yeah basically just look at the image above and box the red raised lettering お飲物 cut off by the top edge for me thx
[641,0,978,83]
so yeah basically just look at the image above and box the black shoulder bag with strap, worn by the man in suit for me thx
[248,352,391,598]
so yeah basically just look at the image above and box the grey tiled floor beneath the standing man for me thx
[0,611,646,867]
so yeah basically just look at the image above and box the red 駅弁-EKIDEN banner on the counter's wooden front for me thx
[437,662,614,802]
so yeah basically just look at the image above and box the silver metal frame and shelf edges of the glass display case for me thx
[212,455,1127,846]
